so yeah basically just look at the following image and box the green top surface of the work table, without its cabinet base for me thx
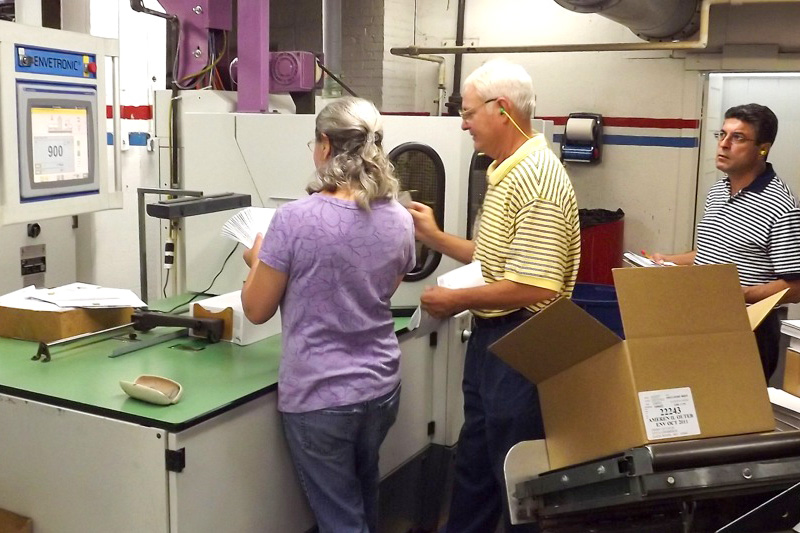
[0,317,409,431]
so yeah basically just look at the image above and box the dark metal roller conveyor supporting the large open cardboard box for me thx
[507,431,800,533]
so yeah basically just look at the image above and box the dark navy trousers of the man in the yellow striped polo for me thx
[446,318,544,533]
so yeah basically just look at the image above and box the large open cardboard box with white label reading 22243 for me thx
[491,265,782,469]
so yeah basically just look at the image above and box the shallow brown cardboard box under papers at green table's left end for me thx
[0,306,133,342]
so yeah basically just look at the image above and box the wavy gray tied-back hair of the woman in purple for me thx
[306,97,400,210]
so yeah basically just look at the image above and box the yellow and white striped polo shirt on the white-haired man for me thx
[473,134,581,318]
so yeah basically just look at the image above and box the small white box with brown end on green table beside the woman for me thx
[192,291,281,346]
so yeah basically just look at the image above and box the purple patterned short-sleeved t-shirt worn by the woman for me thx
[258,193,415,413]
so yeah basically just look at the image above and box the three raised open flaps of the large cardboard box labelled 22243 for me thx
[490,265,788,383]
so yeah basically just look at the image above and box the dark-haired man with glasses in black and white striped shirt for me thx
[653,104,800,381]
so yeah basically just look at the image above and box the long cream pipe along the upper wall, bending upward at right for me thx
[390,0,800,59]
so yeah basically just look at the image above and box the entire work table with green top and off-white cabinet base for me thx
[0,312,418,533]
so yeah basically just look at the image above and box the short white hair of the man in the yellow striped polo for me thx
[464,59,536,118]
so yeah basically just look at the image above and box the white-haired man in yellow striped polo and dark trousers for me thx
[409,60,580,533]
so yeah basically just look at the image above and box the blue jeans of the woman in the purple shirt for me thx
[282,386,400,533]
